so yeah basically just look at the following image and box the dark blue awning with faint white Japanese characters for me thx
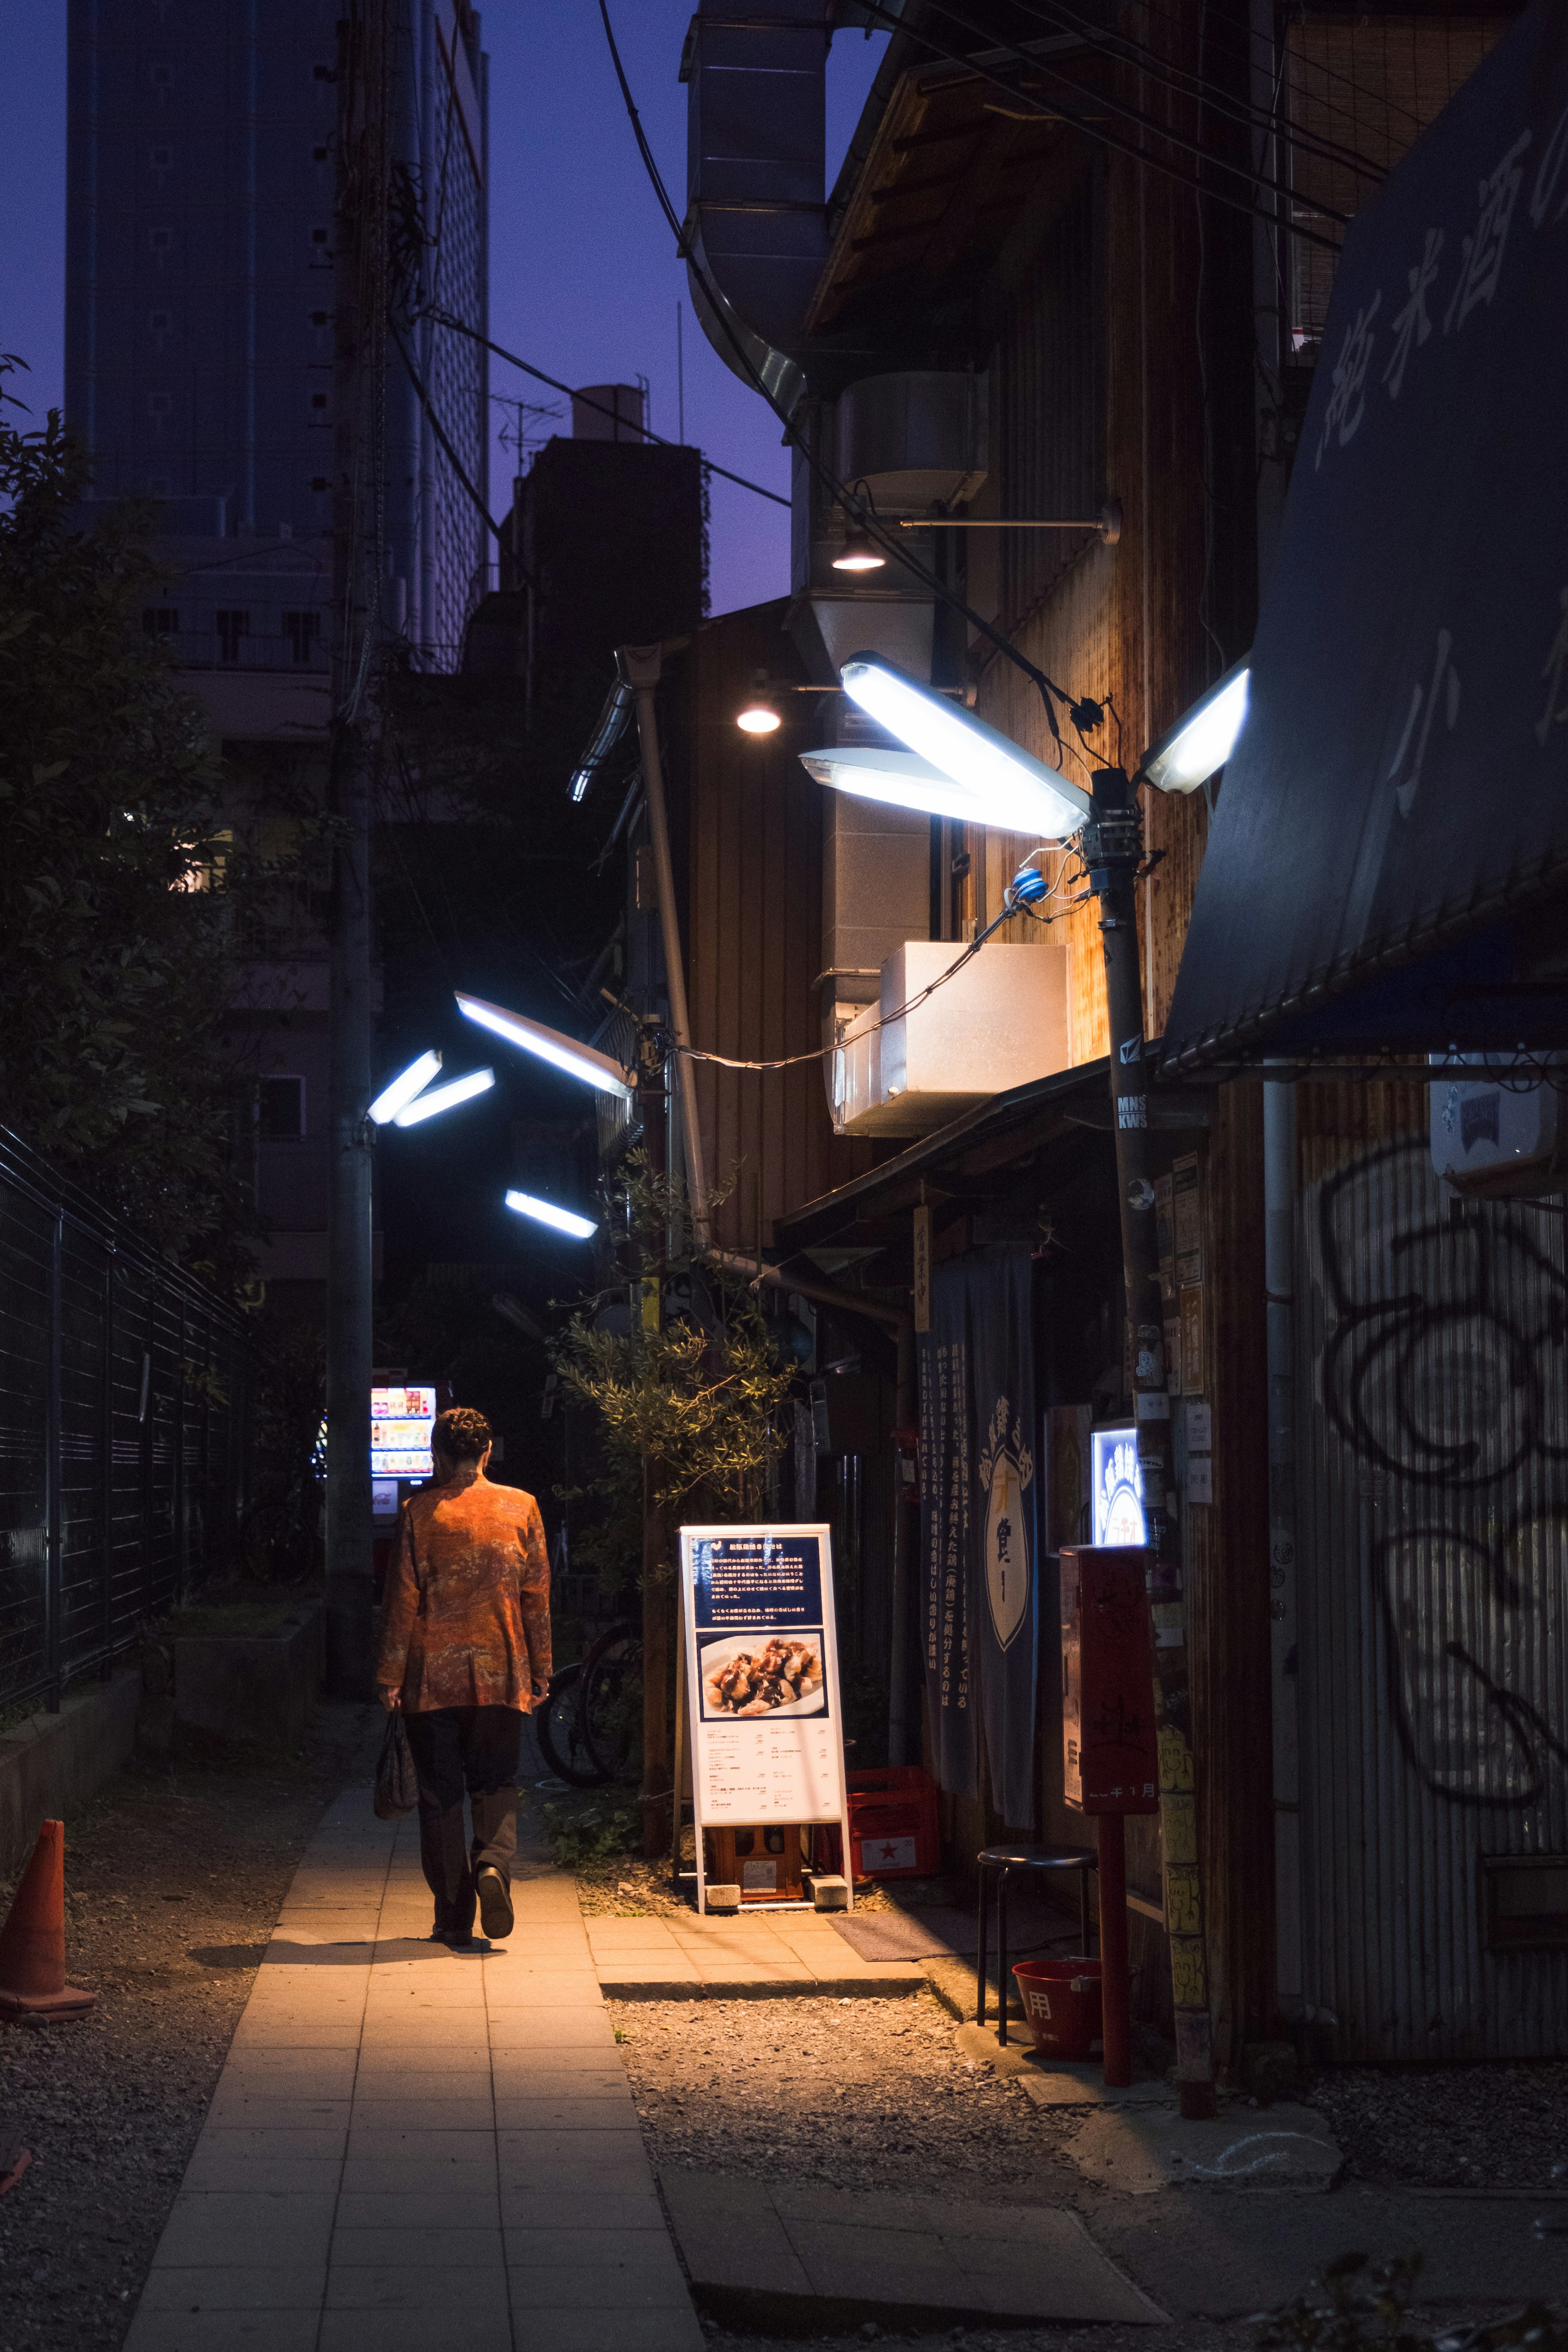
[1166,0,1568,1068]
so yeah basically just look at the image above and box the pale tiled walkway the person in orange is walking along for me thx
[125,1788,703,2352]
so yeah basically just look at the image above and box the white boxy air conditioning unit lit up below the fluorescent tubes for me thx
[825,938,1072,1136]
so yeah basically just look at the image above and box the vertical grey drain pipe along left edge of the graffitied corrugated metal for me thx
[1263,1082,1307,2023]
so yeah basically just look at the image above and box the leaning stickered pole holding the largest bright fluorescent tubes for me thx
[1079,767,1215,2122]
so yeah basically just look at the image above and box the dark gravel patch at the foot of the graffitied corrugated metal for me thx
[1305,2063,1568,2192]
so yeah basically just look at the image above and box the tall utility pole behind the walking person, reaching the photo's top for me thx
[327,0,390,1698]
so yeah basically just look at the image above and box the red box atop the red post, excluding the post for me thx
[1060,1543,1159,1813]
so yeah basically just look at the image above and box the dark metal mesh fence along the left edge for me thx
[0,1129,249,1705]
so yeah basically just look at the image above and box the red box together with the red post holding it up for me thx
[1060,1543,1159,2086]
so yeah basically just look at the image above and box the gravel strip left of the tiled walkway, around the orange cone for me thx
[0,1708,376,2352]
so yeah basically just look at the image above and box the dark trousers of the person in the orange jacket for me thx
[404,1708,522,1936]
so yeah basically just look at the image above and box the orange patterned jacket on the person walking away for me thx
[376,1477,550,1715]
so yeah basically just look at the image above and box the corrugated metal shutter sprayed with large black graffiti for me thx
[1298,1087,1568,2058]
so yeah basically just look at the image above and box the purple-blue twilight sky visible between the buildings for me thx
[0,0,886,612]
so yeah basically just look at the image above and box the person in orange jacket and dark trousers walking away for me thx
[376,1404,550,1950]
